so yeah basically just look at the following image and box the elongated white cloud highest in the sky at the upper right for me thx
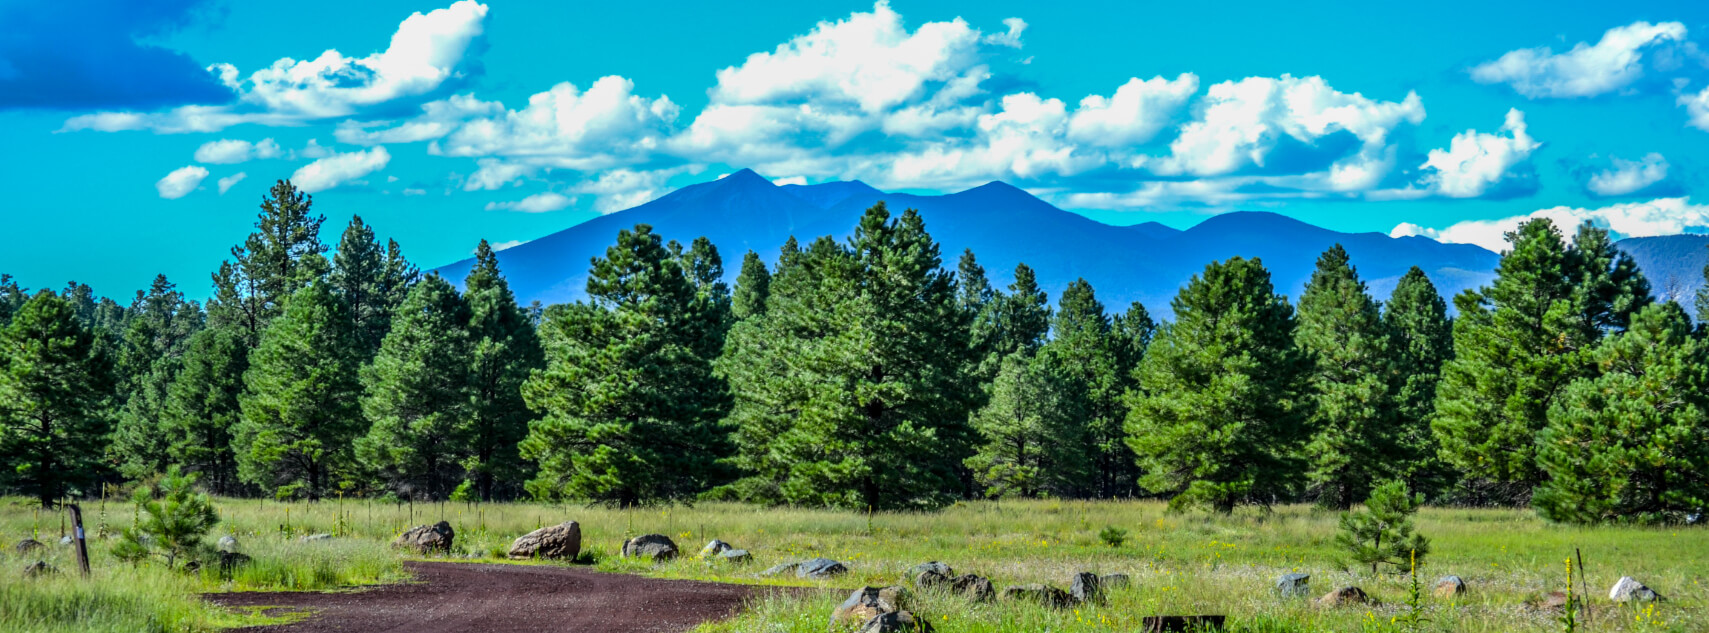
[1471,22,1685,99]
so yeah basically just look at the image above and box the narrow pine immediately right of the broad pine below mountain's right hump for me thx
[1294,245,1401,510]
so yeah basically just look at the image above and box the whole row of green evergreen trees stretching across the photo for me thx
[0,181,1709,522]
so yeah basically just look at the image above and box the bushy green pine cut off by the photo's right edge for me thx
[1531,301,1709,524]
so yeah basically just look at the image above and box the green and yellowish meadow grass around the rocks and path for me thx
[0,500,1709,633]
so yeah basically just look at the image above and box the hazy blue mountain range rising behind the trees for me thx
[438,169,1499,315]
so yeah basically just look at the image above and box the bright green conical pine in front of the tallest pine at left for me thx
[232,281,366,500]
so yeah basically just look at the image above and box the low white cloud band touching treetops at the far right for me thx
[1389,197,1709,253]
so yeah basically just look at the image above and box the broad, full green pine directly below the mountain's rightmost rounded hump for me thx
[1126,257,1311,513]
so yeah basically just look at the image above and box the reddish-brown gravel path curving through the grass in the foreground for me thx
[207,563,782,633]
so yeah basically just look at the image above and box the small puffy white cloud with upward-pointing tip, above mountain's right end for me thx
[1422,109,1542,198]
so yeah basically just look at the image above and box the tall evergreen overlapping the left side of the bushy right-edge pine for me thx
[1432,219,1649,491]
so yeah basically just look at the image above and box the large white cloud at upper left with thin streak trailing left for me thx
[65,0,487,133]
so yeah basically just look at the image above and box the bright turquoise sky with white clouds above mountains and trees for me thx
[0,0,1709,298]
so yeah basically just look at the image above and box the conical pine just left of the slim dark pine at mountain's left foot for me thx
[355,274,475,500]
